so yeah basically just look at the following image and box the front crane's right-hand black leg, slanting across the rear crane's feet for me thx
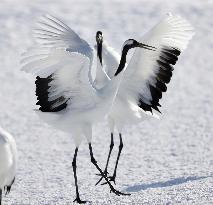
[89,143,130,196]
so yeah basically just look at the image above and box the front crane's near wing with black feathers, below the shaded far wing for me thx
[22,49,97,112]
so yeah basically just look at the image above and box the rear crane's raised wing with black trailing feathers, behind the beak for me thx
[118,14,193,112]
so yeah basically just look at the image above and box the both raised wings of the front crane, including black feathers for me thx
[22,15,97,112]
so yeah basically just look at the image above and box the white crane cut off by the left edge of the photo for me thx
[0,127,17,205]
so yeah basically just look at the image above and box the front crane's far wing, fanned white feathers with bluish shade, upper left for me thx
[33,15,93,59]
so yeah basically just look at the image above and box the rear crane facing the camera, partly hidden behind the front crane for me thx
[95,14,194,184]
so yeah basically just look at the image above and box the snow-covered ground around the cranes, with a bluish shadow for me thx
[0,0,213,205]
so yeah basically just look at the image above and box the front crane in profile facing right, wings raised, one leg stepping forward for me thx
[22,15,155,203]
